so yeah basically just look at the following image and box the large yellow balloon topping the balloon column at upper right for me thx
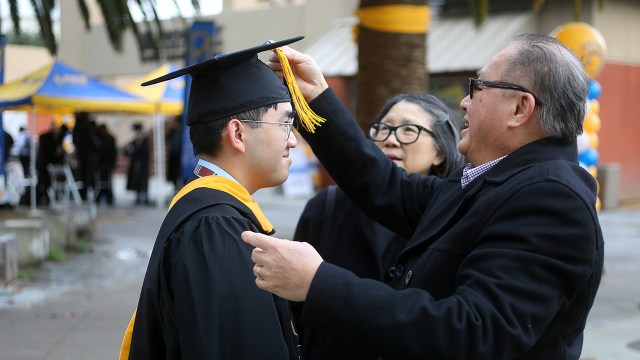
[549,22,607,79]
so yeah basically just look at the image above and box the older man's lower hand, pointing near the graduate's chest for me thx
[242,231,322,301]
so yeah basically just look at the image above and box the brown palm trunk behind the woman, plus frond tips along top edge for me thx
[356,0,605,129]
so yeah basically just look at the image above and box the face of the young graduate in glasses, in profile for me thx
[247,103,298,188]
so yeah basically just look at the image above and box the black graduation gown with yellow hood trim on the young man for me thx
[121,176,299,360]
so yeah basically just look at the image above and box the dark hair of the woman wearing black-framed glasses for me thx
[375,93,463,178]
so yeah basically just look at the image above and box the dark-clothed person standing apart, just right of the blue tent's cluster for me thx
[125,123,149,205]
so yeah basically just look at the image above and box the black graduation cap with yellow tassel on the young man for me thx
[142,36,324,132]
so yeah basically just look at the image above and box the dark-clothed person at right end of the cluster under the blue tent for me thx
[96,124,118,206]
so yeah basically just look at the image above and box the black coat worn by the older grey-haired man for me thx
[301,90,603,360]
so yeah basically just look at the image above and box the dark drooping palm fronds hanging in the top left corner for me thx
[0,0,200,57]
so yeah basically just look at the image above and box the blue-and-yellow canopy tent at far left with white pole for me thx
[0,60,155,209]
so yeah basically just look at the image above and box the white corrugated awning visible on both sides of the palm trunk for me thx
[305,12,537,76]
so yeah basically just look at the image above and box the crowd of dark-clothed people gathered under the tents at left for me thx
[3,112,158,207]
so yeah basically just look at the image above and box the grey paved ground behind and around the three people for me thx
[0,184,640,360]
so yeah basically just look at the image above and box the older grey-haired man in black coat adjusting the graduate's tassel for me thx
[242,34,604,360]
